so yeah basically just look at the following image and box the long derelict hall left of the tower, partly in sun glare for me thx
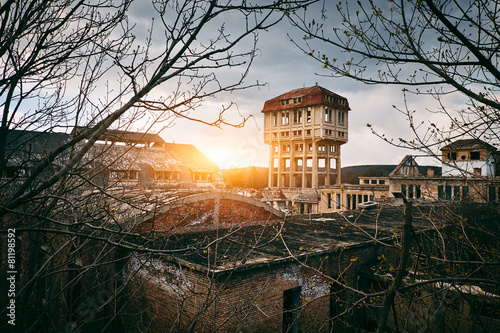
[6,128,223,188]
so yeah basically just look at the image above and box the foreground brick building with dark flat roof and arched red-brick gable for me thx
[121,192,499,332]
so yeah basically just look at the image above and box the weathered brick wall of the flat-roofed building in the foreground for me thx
[118,237,390,332]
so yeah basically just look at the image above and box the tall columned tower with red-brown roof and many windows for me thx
[262,85,350,188]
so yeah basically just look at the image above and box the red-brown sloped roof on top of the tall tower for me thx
[262,85,350,112]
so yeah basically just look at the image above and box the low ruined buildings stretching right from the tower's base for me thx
[320,147,500,212]
